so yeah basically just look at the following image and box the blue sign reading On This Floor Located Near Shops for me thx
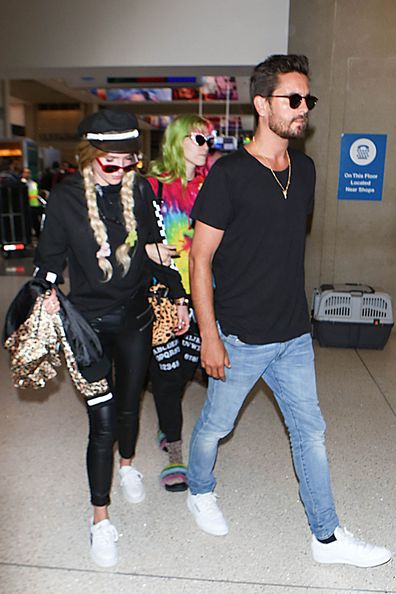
[338,134,386,200]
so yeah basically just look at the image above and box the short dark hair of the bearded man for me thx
[250,54,309,101]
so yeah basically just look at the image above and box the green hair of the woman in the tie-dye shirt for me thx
[147,114,213,186]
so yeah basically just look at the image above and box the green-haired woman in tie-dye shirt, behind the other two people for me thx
[146,114,213,492]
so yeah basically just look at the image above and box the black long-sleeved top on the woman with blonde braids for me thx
[34,173,185,319]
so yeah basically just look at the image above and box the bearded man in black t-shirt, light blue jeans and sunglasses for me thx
[187,55,391,567]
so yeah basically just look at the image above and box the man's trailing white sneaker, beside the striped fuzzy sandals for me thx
[187,491,228,536]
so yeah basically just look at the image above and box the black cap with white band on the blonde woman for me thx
[78,109,140,153]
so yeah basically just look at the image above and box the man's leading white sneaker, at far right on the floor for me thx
[311,527,392,567]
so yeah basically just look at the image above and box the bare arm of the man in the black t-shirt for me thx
[190,221,231,379]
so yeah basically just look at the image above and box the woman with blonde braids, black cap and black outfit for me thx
[35,109,188,567]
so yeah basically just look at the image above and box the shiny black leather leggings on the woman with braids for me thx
[87,299,152,506]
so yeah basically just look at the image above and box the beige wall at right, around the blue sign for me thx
[289,0,396,316]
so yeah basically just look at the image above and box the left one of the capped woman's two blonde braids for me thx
[82,165,113,282]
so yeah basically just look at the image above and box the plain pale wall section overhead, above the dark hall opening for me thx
[0,0,289,78]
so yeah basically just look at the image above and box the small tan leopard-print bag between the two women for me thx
[148,283,177,346]
